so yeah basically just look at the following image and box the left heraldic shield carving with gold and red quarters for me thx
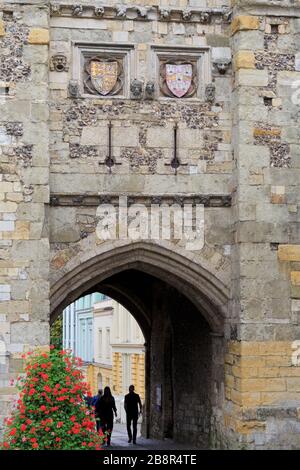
[84,57,124,96]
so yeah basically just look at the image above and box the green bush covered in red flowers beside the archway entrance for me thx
[1,347,103,450]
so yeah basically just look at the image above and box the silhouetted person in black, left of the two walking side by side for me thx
[95,387,117,446]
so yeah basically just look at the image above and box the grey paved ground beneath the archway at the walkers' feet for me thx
[105,424,197,451]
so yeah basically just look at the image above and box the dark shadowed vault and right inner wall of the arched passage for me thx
[52,246,227,448]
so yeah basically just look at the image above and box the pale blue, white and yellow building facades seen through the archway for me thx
[63,293,145,422]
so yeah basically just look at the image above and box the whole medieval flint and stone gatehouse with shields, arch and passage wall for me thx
[0,0,300,449]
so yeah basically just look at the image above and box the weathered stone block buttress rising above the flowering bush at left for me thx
[0,2,49,434]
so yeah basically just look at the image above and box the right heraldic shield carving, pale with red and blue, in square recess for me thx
[160,61,197,98]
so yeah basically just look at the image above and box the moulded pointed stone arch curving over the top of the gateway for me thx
[50,241,230,335]
